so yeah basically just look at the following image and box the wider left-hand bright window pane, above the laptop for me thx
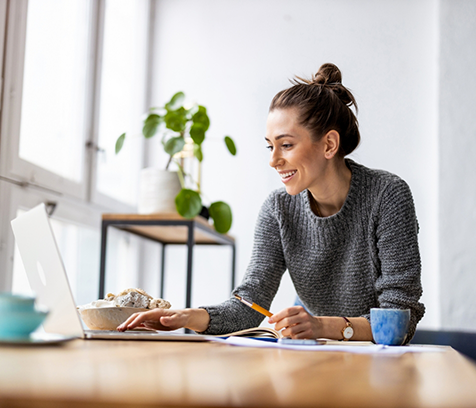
[19,0,91,183]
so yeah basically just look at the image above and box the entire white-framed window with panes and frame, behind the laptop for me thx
[0,0,152,303]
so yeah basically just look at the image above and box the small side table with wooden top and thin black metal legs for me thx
[98,213,236,308]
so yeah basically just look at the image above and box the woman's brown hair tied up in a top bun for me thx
[269,63,360,157]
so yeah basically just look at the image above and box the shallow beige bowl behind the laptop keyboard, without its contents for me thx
[79,307,149,330]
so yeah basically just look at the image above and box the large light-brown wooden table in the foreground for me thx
[0,340,476,408]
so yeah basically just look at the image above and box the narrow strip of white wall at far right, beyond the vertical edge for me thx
[439,0,476,330]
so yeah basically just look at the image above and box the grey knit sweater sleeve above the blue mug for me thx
[375,179,425,342]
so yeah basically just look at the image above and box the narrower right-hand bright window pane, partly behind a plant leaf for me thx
[96,0,148,205]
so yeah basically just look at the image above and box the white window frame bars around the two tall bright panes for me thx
[0,0,155,291]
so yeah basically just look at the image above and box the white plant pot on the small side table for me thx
[137,167,182,214]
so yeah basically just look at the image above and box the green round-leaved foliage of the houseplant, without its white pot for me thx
[115,92,236,233]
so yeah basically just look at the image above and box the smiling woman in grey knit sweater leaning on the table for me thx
[118,64,425,341]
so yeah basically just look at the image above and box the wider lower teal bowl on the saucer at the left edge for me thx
[0,310,48,340]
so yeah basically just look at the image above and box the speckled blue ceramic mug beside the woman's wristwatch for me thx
[370,308,410,346]
